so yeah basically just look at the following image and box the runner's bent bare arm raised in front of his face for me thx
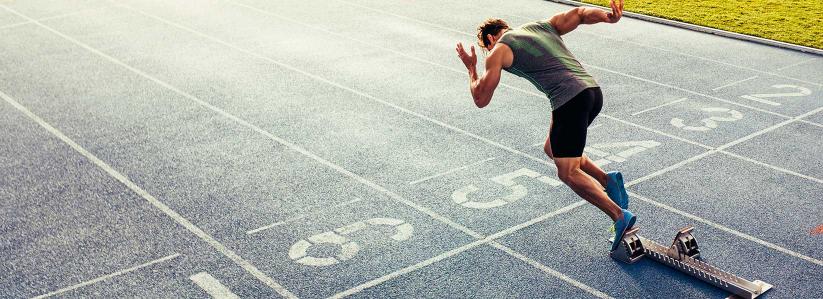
[456,43,514,108]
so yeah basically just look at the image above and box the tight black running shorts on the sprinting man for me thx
[549,87,603,158]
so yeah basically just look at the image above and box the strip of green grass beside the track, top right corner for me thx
[578,0,823,49]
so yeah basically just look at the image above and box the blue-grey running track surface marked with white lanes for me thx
[0,0,823,298]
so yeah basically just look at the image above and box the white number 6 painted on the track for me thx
[289,218,414,267]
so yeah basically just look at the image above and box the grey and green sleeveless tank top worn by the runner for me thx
[499,21,598,110]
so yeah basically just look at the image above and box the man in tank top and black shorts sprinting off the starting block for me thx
[456,0,636,251]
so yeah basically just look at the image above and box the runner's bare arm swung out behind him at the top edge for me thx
[549,0,623,35]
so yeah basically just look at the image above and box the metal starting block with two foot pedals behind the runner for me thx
[609,226,773,299]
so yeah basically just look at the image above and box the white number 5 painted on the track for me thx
[452,168,563,210]
